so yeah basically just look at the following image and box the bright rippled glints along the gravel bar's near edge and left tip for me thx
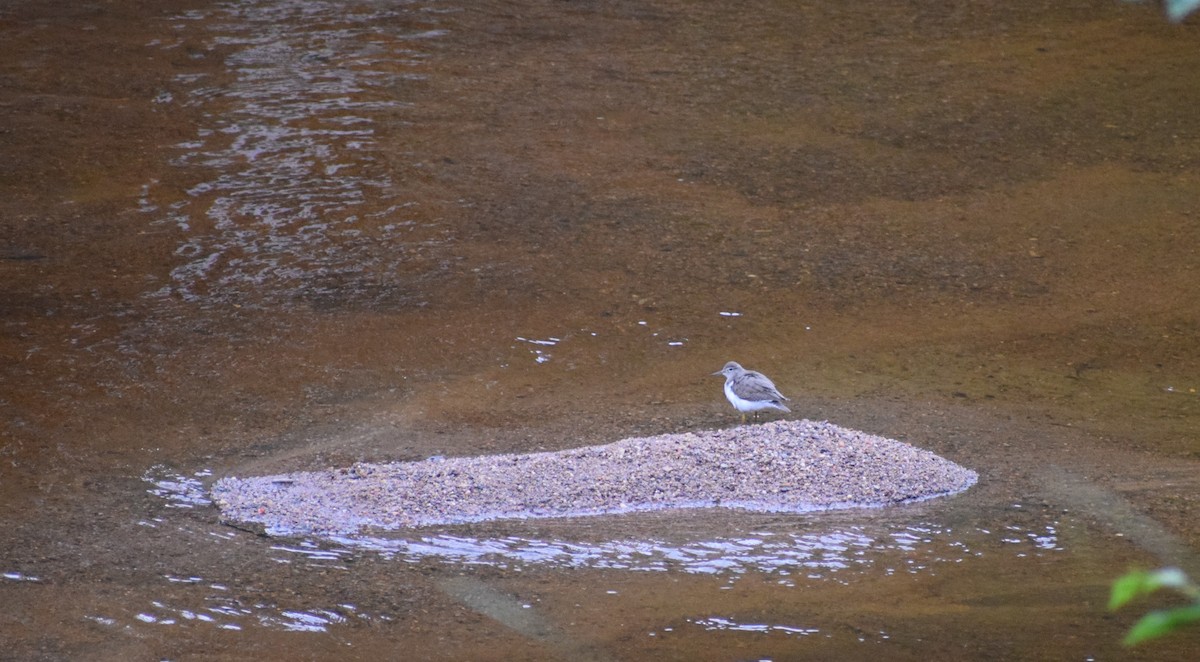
[144,465,1063,586]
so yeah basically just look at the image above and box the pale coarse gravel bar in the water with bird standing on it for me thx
[212,421,978,535]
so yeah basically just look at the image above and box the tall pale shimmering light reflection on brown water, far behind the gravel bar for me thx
[147,0,444,306]
